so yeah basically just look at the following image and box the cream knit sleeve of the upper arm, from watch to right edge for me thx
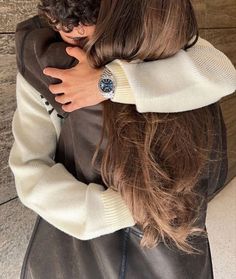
[107,38,236,113]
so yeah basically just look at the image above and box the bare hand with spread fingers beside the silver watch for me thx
[43,47,106,112]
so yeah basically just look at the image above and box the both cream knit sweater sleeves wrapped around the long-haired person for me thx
[9,39,236,240]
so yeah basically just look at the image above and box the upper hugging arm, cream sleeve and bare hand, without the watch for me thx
[46,38,236,113]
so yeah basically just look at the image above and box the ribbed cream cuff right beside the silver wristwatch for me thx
[106,60,136,104]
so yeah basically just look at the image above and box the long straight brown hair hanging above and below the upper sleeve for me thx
[39,0,217,253]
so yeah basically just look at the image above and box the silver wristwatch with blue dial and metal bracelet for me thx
[98,67,116,99]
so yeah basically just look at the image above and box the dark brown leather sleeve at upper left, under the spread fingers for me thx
[15,16,77,117]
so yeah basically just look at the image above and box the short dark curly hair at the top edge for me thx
[38,0,101,32]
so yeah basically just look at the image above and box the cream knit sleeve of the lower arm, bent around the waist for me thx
[9,74,135,240]
